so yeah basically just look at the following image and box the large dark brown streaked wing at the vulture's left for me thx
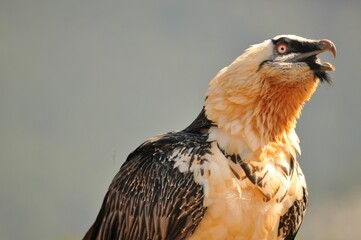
[84,129,210,240]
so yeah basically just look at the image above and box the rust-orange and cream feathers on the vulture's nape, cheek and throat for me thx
[205,53,319,154]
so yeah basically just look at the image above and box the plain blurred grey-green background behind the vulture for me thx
[0,0,361,240]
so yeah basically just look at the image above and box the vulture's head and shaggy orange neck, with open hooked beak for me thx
[205,35,336,152]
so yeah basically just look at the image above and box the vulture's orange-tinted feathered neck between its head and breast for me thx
[205,65,318,157]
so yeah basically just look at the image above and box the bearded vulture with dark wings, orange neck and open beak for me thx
[84,34,336,240]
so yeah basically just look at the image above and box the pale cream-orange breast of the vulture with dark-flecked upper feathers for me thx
[171,142,305,240]
